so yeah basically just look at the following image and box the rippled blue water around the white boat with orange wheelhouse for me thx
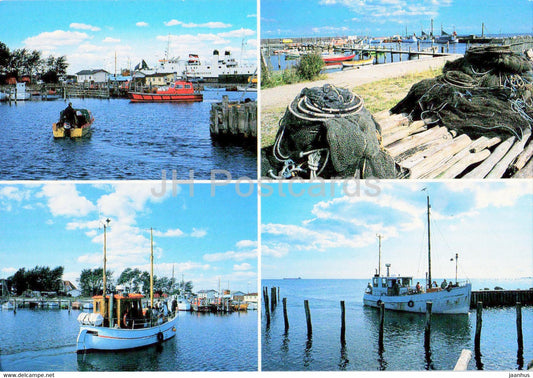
[0,309,258,371]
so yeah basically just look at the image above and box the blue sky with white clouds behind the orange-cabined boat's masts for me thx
[0,181,258,292]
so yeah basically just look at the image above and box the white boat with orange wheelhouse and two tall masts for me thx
[76,220,177,353]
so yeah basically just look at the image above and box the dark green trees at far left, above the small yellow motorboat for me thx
[0,42,68,84]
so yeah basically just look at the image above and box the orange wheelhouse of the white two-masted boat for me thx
[93,293,151,328]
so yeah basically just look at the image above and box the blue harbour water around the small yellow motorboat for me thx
[0,91,257,180]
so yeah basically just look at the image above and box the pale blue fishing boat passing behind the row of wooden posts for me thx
[363,196,472,314]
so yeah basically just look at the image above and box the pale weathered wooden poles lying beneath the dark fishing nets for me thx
[374,110,533,179]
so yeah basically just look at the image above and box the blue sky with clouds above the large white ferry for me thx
[0,0,257,73]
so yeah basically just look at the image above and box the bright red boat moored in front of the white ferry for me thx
[128,80,204,102]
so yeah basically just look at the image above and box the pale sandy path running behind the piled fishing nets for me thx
[260,54,462,112]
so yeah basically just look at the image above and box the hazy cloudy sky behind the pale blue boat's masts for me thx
[261,180,533,279]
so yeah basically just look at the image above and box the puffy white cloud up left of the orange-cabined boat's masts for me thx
[37,182,96,217]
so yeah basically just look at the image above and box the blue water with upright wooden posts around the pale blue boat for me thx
[261,279,533,371]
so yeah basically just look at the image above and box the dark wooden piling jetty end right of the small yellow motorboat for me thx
[209,96,257,140]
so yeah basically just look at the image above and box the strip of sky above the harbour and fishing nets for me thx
[261,0,533,38]
